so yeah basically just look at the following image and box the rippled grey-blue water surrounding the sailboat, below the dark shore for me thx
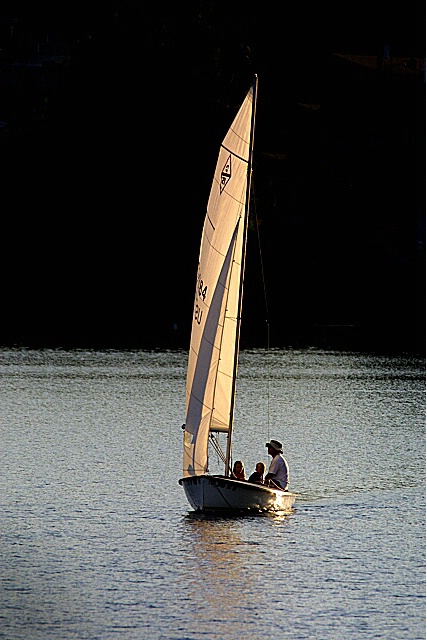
[0,350,426,640]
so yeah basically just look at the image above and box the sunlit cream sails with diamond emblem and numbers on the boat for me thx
[183,86,255,477]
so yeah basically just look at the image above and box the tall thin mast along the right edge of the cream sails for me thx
[225,74,258,476]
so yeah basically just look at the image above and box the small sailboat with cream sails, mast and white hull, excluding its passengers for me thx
[179,76,296,513]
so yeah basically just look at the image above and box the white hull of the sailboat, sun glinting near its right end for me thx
[179,475,296,513]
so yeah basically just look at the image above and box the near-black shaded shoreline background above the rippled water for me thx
[0,1,426,352]
